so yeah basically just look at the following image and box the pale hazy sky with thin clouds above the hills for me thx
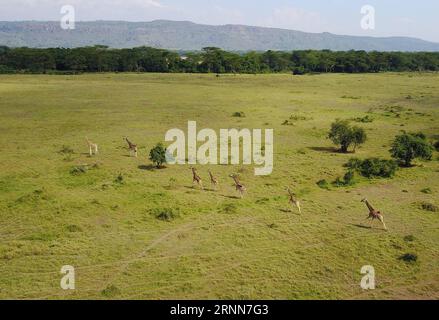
[0,0,439,42]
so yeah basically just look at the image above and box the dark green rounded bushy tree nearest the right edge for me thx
[390,133,433,167]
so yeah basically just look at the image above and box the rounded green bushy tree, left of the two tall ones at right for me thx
[328,120,367,153]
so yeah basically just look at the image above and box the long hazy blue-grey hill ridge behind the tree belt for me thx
[0,20,439,51]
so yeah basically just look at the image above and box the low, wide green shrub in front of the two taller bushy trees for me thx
[346,158,398,178]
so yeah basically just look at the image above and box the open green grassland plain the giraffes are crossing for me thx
[0,73,439,299]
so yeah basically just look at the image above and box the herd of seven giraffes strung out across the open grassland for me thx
[85,137,387,231]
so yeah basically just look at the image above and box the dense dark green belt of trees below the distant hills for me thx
[0,46,439,74]
